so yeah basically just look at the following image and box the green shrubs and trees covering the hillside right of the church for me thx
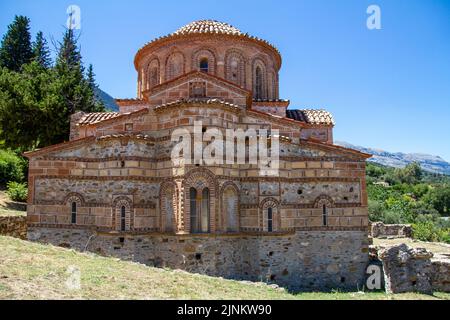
[367,163,450,242]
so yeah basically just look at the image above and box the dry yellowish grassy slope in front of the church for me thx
[0,236,450,299]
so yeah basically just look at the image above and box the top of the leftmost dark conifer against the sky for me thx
[0,16,33,71]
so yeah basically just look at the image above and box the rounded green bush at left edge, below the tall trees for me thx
[0,150,27,185]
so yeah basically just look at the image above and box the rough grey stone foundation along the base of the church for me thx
[28,228,369,291]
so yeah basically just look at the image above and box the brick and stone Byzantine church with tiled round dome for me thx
[26,20,369,290]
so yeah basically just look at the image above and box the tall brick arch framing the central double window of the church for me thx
[182,168,218,233]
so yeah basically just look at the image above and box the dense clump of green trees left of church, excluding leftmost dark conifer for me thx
[0,18,105,151]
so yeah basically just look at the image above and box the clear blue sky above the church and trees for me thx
[0,0,450,160]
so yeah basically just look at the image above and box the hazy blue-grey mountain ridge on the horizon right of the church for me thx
[335,141,450,175]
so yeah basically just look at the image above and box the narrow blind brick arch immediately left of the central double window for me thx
[159,181,179,232]
